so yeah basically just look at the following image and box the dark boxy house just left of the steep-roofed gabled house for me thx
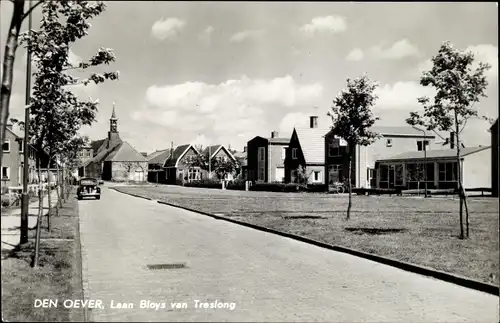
[246,131,290,183]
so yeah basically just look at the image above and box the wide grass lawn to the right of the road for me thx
[116,185,499,285]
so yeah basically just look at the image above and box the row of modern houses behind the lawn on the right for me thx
[245,116,498,194]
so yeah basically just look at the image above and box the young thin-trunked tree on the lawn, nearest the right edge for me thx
[406,41,491,239]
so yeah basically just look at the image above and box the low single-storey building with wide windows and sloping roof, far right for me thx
[376,146,491,189]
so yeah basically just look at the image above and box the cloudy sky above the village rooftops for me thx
[0,1,498,152]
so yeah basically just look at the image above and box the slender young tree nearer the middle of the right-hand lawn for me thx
[328,75,378,220]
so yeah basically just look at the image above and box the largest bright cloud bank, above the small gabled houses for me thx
[132,75,323,146]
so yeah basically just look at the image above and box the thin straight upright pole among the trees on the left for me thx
[20,1,32,244]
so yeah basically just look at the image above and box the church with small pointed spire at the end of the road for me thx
[78,104,148,182]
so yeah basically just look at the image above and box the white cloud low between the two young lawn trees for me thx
[375,82,435,109]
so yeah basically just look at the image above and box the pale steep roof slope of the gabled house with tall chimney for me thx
[294,128,331,164]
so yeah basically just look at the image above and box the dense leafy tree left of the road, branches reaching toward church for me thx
[21,0,118,266]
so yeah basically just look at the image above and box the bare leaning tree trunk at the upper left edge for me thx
[0,0,24,170]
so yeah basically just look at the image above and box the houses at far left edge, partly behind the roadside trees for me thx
[0,124,57,191]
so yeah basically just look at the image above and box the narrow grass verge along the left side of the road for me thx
[2,191,84,322]
